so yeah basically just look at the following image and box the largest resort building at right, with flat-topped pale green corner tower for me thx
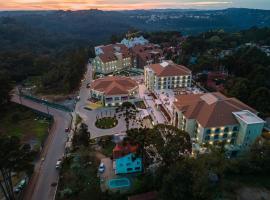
[173,92,265,149]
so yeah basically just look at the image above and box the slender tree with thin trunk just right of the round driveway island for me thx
[116,102,138,131]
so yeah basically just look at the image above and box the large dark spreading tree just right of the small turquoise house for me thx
[127,124,191,166]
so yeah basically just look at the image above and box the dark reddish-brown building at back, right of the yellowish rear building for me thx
[131,44,164,69]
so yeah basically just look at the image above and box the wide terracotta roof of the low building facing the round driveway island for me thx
[91,76,138,95]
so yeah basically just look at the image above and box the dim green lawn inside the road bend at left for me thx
[0,104,50,145]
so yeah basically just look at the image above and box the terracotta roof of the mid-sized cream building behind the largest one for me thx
[150,61,191,77]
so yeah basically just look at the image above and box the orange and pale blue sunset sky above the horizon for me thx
[0,0,270,10]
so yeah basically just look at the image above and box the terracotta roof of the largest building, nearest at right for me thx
[174,92,256,127]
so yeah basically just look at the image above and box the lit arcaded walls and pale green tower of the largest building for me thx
[174,108,265,149]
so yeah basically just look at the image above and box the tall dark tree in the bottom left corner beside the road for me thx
[0,135,34,200]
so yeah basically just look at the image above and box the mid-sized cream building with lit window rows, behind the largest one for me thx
[144,61,192,91]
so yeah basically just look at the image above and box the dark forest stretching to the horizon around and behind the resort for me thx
[0,9,270,113]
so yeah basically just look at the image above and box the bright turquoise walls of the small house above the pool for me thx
[115,153,142,174]
